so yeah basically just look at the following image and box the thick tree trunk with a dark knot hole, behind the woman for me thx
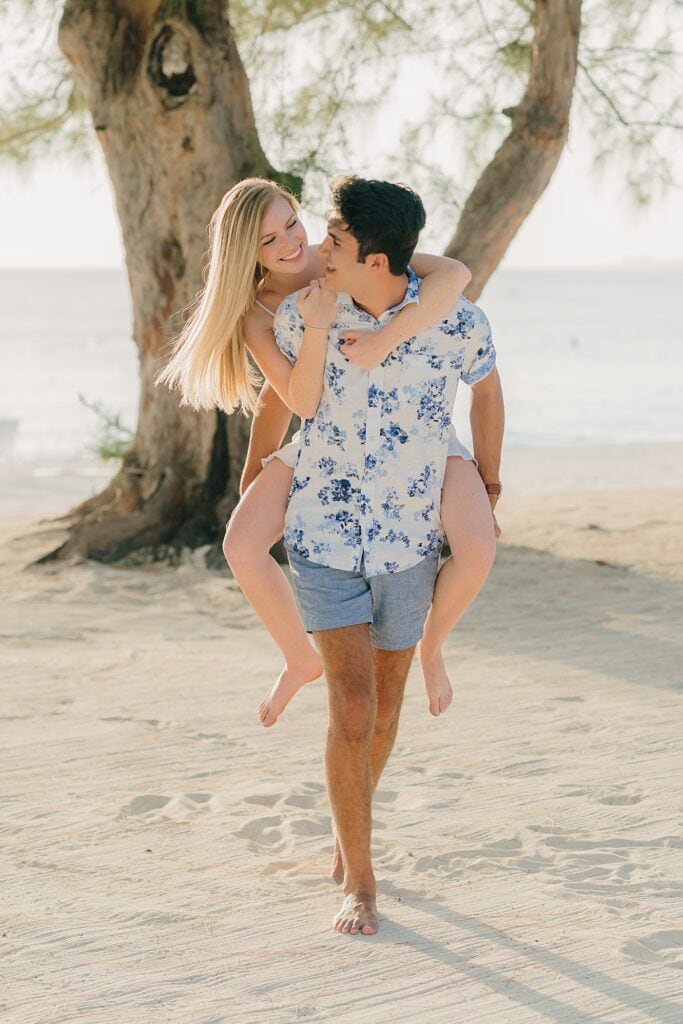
[42,0,284,561]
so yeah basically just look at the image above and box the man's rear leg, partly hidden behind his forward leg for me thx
[332,647,415,883]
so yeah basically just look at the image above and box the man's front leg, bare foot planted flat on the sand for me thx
[314,624,378,935]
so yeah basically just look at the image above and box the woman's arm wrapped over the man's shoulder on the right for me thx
[343,253,472,370]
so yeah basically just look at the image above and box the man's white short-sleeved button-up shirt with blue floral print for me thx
[274,268,496,577]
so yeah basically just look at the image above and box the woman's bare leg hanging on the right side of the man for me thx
[420,456,496,716]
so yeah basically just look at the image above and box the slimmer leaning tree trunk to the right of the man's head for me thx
[445,0,581,300]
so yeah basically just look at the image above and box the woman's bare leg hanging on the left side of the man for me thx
[223,459,323,726]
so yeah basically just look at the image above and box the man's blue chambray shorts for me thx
[287,548,440,650]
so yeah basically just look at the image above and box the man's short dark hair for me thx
[330,174,427,275]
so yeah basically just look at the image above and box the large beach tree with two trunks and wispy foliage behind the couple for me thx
[0,0,675,561]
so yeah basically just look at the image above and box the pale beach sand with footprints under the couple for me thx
[0,459,683,1024]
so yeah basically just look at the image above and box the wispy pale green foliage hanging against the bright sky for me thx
[0,0,683,208]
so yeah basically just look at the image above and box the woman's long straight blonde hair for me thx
[156,178,298,415]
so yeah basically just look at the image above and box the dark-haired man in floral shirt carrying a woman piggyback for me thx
[274,177,502,935]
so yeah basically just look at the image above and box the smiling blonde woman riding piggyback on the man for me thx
[158,178,495,727]
